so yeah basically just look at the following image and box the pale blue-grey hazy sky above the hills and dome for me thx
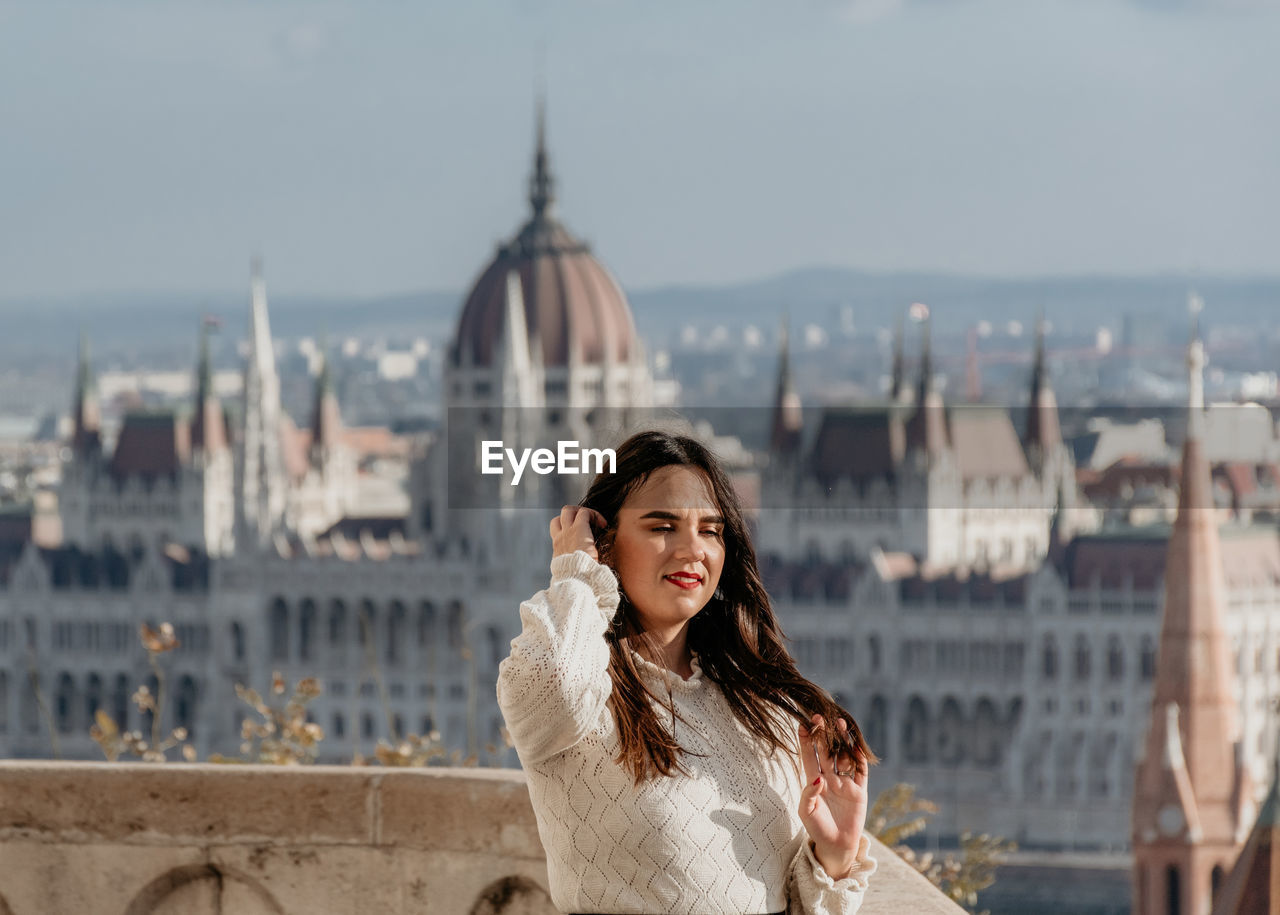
[0,0,1280,299]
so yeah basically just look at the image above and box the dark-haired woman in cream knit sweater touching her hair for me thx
[498,433,876,915]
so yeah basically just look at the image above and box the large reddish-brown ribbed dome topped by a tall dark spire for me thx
[452,111,639,366]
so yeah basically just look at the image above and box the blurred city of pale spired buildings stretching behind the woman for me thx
[0,118,1280,914]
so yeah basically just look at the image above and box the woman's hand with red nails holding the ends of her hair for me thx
[799,715,867,880]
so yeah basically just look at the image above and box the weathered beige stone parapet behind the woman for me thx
[0,761,963,915]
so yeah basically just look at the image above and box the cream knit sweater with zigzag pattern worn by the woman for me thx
[498,552,876,915]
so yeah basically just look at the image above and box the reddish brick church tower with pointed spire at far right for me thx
[1133,310,1252,915]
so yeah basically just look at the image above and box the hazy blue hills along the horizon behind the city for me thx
[0,267,1280,357]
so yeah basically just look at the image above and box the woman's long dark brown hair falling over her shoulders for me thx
[581,431,876,783]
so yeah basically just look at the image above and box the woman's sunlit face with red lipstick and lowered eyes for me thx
[611,466,724,633]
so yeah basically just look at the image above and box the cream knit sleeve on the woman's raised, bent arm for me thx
[498,550,618,768]
